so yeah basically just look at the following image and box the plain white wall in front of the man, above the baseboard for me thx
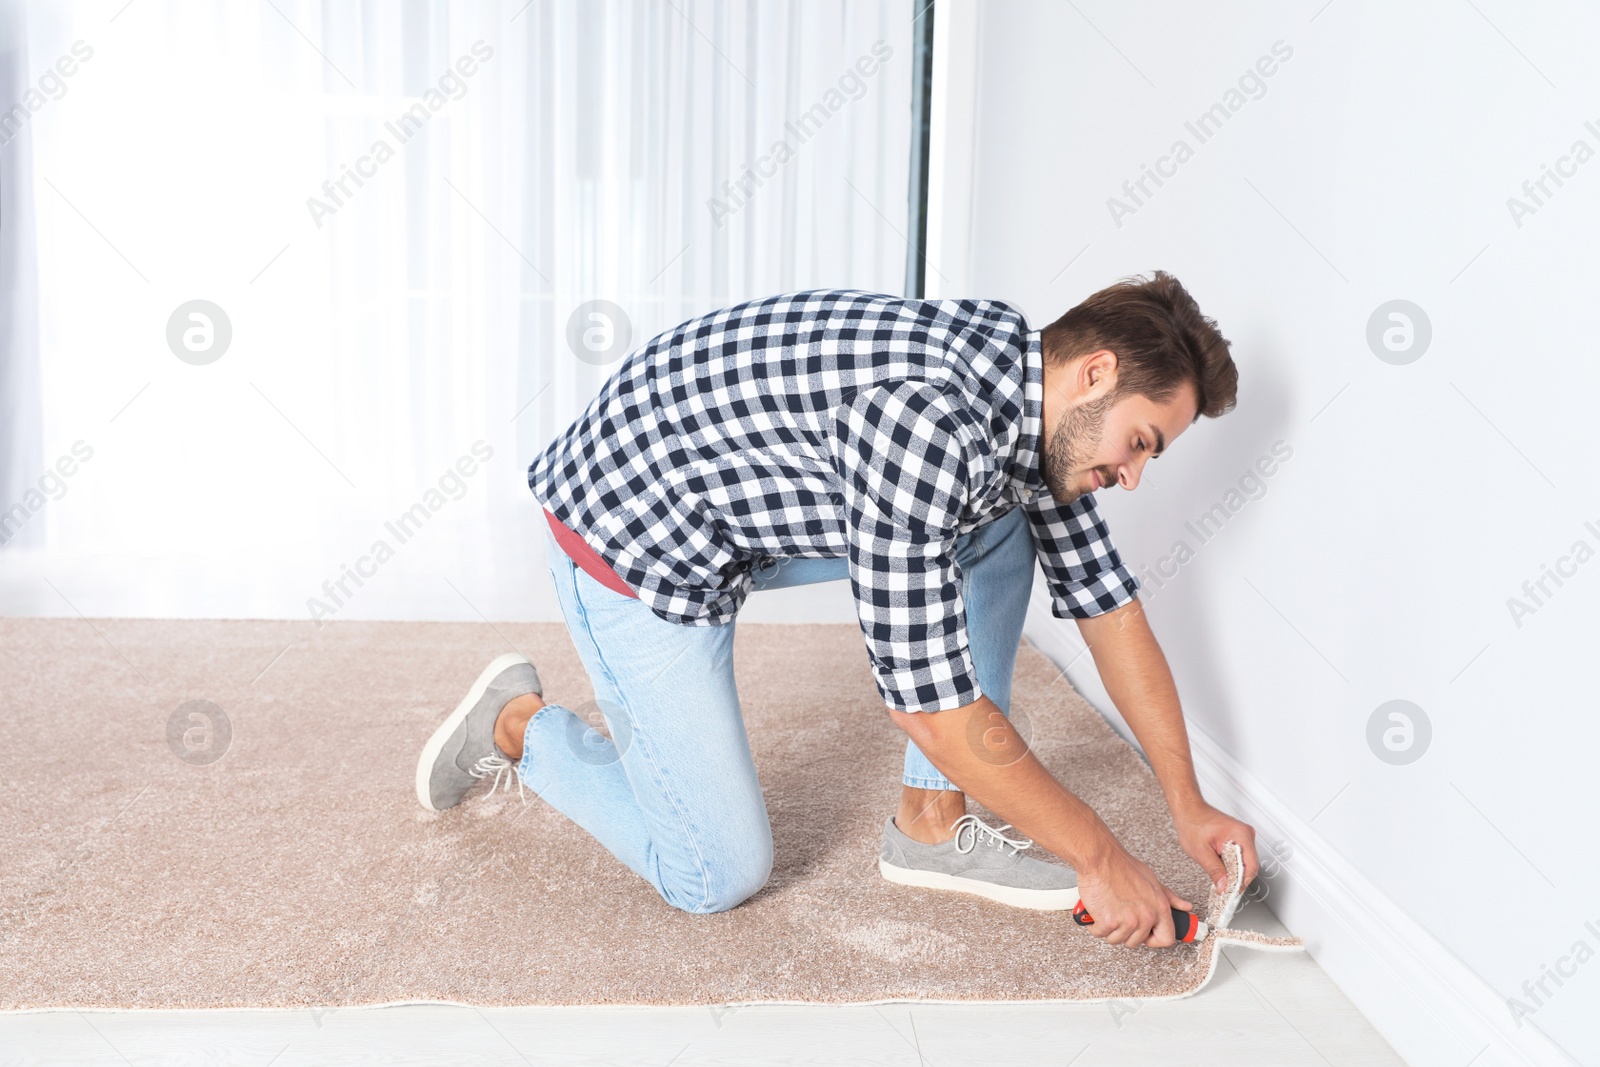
[930,0,1600,1064]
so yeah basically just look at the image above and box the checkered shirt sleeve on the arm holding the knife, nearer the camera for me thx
[834,381,982,712]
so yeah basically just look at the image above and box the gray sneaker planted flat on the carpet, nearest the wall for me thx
[878,816,1078,912]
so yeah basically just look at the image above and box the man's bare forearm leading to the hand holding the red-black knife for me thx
[890,697,1123,873]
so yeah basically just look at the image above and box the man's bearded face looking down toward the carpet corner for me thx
[1040,377,1197,504]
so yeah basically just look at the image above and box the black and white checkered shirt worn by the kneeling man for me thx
[528,290,1139,712]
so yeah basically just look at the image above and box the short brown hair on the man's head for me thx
[1040,270,1238,421]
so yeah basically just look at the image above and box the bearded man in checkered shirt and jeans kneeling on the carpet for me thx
[418,272,1256,947]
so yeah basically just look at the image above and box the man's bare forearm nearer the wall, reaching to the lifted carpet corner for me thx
[1078,600,1205,814]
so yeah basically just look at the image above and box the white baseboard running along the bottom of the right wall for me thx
[1022,605,1578,1067]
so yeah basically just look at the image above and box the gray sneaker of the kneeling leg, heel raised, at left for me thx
[416,653,544,811]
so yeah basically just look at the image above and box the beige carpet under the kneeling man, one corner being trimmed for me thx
[0,619,1299,1009]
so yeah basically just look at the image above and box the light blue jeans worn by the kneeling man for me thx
[517,509,1035,913]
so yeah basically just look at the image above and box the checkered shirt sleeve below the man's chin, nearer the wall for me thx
[1024,493,1139,619]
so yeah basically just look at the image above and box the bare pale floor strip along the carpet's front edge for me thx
[0,904,1403,1067]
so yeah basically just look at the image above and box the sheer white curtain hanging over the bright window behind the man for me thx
[0,0,915,617]
